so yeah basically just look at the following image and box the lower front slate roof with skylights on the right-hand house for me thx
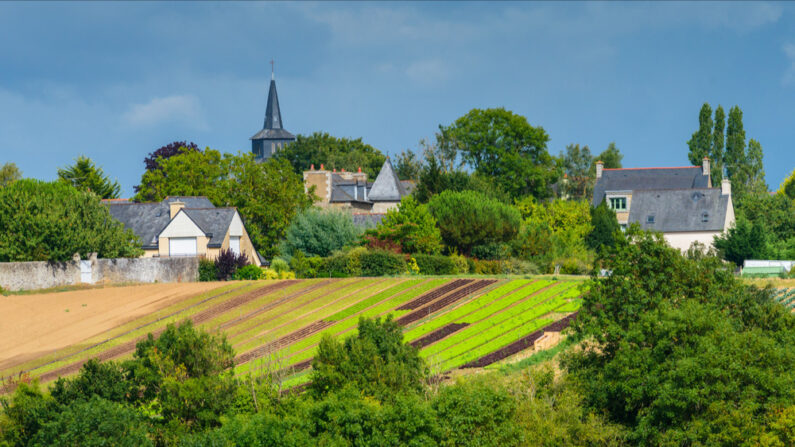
[629,188,730,233]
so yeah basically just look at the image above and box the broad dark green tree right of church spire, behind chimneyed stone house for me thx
[276,132,386,179]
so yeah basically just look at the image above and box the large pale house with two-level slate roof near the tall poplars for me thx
[592,158,734,250]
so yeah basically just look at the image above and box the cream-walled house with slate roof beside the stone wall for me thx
[103,196,261,265]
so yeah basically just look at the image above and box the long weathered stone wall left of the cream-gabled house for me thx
[0,257,199,290]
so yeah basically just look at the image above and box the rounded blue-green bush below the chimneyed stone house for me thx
[279,208,363,257]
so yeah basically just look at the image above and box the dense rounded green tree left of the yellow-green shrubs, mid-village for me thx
[428,191,521,254]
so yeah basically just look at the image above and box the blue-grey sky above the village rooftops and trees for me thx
[0,2,795,196]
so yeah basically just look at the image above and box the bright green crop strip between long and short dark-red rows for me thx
[405,280,549,340]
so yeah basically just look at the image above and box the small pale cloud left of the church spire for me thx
[123,95,207,129]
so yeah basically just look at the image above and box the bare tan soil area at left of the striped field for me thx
[0,282,223,370]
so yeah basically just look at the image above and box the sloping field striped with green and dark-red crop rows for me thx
[0,277,582,387]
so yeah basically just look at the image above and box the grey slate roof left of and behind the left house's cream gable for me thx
[105,196,219,250]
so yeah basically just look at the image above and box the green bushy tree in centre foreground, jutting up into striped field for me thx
[310,316,427,400]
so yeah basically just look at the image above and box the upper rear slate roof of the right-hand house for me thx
[592,166,710,207]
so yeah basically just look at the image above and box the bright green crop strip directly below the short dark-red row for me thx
[423,283,572,357]
